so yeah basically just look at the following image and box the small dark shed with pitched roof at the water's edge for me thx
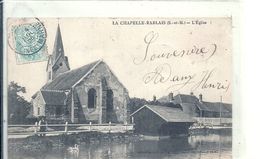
[130,105,195,136]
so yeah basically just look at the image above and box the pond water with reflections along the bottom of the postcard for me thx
[9,130,232,159]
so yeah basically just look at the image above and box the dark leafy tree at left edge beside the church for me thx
[8,81,31,124]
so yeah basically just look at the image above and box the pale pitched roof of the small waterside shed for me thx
[131,105,195,122]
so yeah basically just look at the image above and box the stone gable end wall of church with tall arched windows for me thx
[75,62,129,123]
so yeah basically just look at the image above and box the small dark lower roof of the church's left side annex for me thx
[41,90,66,105]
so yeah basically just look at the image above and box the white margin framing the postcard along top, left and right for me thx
[3,1,242,159]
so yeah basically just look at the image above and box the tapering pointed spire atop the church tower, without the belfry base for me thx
[52,24,64,63]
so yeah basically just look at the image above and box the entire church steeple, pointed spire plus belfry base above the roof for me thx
[46,24,70,82]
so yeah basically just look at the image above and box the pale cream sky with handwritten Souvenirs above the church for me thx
[7,18,232,103]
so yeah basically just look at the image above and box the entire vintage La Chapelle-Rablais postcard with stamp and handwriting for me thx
[7,17,233,159]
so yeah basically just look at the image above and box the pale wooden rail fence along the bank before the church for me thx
[8,122,134,135]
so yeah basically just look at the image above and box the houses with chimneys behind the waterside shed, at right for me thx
[158,93,232,118]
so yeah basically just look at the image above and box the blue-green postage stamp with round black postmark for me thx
[8,21,48,64]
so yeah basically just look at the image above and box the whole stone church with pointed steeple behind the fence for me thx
[32,25,129,124]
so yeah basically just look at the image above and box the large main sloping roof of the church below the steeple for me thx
[42,60,101,90]
